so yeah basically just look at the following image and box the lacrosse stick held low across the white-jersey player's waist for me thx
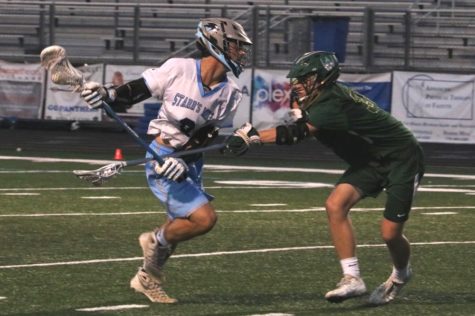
[73,144,226,186]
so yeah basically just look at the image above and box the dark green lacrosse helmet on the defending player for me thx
[287,51,340,86]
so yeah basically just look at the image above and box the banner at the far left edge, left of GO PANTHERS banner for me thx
[0,61,44,119]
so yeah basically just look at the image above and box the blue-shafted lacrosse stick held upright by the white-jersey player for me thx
[40,45,163,165]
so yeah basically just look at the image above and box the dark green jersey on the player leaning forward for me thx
[307,83,417,165]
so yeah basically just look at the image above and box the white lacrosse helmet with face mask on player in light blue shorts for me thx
[196,18,252,77]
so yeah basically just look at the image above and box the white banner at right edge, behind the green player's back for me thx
[391,71,475,144]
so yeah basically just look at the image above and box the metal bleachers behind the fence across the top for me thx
[0,0,475,72]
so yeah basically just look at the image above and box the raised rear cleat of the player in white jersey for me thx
[139,232,174,279]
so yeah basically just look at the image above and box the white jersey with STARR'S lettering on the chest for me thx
[142,58,242,148]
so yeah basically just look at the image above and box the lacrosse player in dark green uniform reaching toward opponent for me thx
[226,51,424,305]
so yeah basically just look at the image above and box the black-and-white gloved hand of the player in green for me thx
[223,123,262,156]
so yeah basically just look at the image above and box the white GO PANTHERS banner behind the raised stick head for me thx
[44,64,104,121]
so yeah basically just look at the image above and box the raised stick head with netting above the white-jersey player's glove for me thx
[40,45,85,91]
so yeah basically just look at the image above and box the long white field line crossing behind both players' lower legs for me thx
[0,241,475,270]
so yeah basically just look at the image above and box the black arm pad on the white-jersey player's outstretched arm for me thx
[110,78,152,112]
